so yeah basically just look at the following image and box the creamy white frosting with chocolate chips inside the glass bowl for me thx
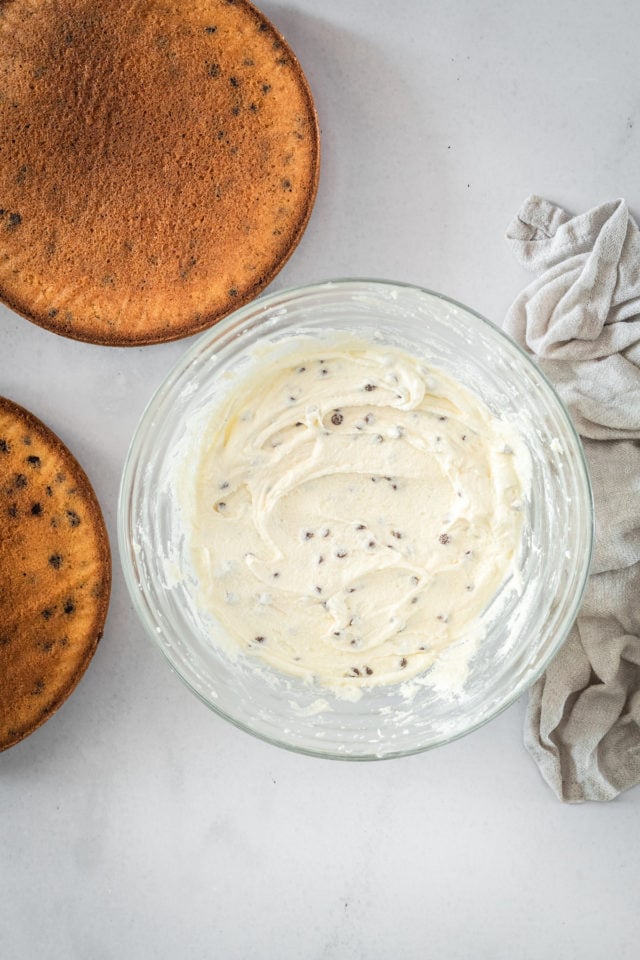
[183,337,528,692]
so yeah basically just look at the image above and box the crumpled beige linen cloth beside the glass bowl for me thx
[505,196,640,802]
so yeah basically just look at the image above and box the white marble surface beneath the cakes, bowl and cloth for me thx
[0,0,640,960]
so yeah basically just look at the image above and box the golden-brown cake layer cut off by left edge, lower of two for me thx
[0,397,111,750]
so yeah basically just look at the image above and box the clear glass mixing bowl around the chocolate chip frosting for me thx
[118,280,593,760]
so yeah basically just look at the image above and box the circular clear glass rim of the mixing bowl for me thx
[117,276,595,762]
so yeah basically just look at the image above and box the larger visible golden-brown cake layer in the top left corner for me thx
[0,0,319,345]
